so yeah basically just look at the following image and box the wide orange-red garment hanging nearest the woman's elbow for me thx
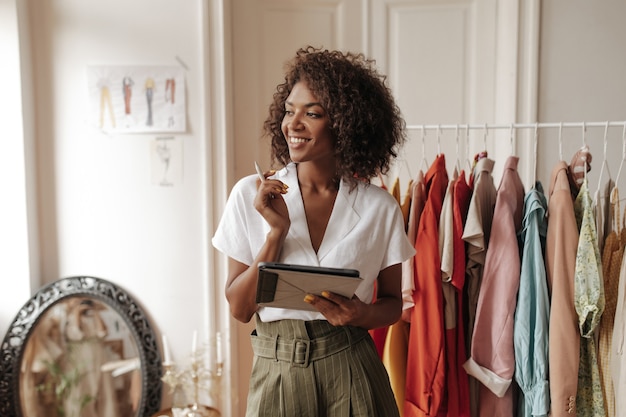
[404,154,448,417]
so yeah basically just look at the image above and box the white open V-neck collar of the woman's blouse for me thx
[281,164,361,266]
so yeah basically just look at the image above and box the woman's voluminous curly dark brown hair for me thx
[263,46,406,185]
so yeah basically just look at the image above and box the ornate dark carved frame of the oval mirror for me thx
[0,276,162,417]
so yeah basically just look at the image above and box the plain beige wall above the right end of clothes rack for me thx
[537,0,626,194]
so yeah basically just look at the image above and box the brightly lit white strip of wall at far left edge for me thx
[0,0,37,334]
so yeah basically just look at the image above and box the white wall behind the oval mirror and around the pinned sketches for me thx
[0,0,227,409]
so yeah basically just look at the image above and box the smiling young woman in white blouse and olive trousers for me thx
[213,47,415,417]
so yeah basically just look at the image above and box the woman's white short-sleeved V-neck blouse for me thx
[212,164,415,322]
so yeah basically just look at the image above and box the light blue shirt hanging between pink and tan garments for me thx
[513,183,550,417]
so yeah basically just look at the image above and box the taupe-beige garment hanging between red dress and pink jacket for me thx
[462,157,497,417]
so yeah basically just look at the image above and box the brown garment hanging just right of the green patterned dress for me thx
[598,187,626,417]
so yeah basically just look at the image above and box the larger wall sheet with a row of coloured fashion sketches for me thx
[87,66,186,133]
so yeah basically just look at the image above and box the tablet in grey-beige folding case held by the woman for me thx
[256,262,362,311]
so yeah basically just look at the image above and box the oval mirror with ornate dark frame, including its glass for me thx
[0,276,162,417]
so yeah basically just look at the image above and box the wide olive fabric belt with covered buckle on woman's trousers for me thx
[252,327,368,368]
